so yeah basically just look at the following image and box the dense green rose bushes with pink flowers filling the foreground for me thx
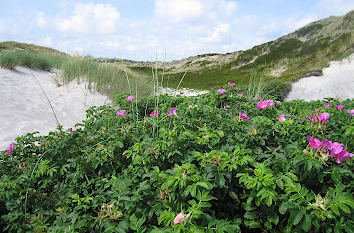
[0,87,354,232]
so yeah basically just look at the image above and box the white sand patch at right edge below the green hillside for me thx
[286,54,354,101]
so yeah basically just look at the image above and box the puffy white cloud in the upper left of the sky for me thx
[37,3,120,34]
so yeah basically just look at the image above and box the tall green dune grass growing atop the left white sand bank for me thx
[0,49,152,99]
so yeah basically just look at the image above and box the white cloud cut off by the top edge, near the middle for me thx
[154,0,237,23]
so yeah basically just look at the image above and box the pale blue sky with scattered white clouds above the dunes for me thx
[0,0,354,61]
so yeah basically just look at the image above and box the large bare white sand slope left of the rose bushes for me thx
[0,67,110,150]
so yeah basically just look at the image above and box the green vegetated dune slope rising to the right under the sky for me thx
[115,11,354,92]
